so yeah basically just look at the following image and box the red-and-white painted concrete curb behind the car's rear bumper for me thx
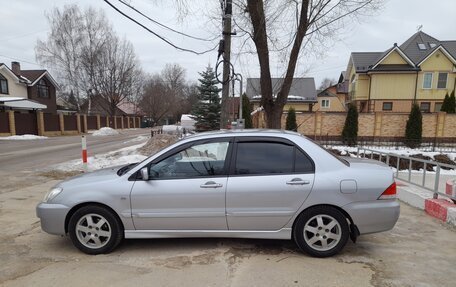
[396,180,456,226]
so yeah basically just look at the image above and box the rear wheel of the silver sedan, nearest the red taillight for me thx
[293,206,349,257]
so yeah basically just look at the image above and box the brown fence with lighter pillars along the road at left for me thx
[0,111,141,136]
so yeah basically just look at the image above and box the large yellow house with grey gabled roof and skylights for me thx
[346,31,456,112]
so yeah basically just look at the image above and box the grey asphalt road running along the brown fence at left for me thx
[0,129,150,174]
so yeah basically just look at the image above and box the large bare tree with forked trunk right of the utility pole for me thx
[239,0,381,128]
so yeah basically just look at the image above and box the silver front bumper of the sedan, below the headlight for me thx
[36,202,70,235]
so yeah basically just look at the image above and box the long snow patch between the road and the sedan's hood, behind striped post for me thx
[51,144,146,172]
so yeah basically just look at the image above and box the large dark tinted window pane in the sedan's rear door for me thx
[235,142,294,174]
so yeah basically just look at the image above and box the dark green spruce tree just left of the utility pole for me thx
[191,67,221,131]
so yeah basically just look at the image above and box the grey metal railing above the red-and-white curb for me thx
[357,147,456,201]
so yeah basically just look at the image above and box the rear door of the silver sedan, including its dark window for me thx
[226,137,315,230]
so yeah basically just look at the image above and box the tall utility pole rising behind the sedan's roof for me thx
[220,0,233,129]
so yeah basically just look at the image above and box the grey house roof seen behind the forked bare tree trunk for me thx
[245,78,317,103]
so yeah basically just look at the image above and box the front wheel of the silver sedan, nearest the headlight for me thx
[68,205,124,255]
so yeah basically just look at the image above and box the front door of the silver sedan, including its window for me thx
[131,138,232,230]
